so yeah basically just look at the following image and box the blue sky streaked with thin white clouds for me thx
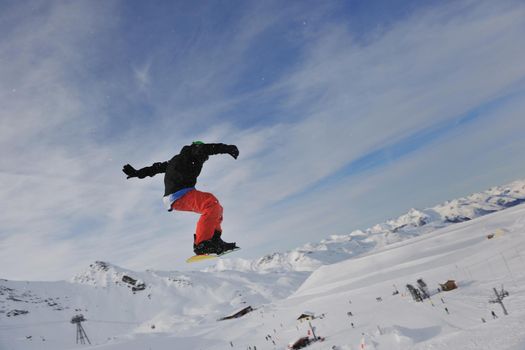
[0,0,525,280]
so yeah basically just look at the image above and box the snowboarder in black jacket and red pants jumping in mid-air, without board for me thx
[122,141,239,255]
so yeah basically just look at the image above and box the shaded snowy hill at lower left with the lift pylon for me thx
[0,261,307,350]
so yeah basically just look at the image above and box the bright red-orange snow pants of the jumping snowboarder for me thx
[171,190,222,244]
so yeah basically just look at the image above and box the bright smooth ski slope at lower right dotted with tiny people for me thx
[286,201,525,349]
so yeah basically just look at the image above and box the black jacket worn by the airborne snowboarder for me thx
[137,143,237,196]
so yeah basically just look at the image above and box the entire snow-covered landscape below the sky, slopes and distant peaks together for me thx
[0,181,525,350]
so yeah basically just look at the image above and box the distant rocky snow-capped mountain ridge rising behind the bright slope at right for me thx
[211,180,525,271]
